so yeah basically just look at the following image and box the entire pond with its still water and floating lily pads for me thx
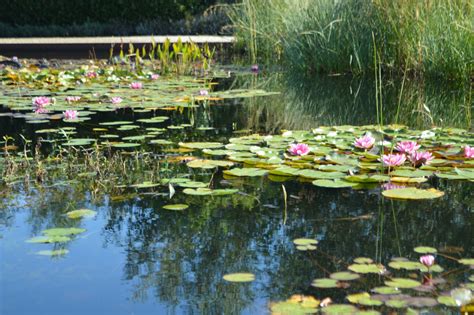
[0,61,474,314]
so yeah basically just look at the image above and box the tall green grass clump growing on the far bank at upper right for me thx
[231,0,474,78]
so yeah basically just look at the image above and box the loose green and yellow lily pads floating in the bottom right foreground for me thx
[223,242,474,315]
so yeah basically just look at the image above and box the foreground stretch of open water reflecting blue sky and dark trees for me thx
[0,179,473,314]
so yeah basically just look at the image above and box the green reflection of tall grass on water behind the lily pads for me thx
[236,74,472,133]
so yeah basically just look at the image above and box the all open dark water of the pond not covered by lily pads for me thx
[0,75,474,314]
